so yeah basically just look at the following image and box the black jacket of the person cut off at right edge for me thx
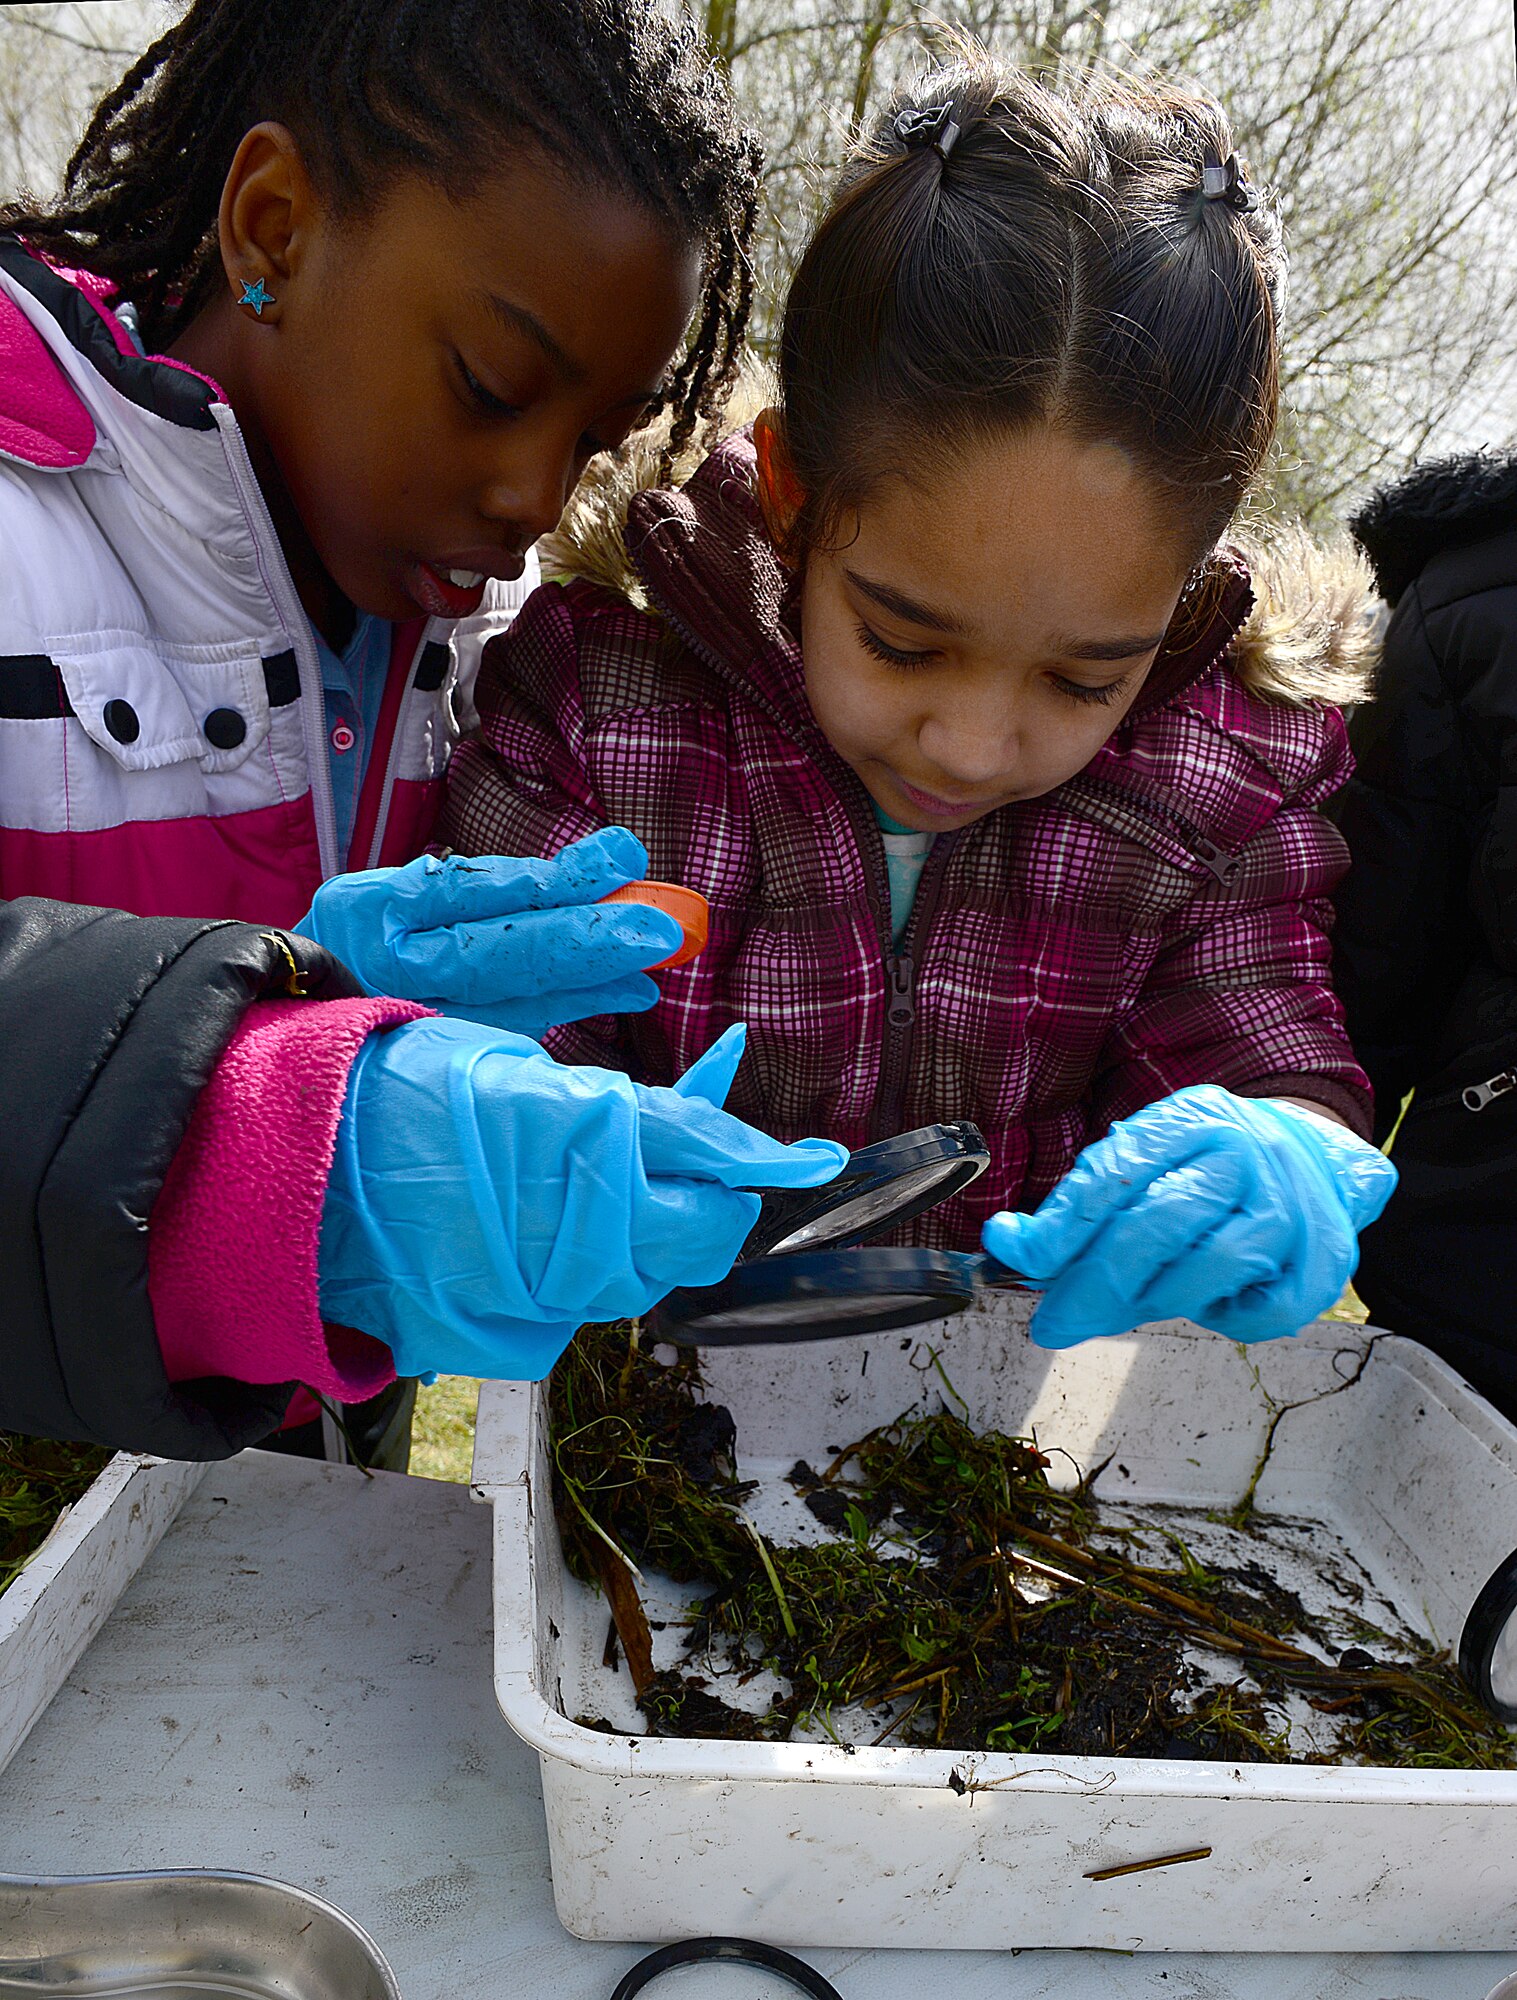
[1329,454,1517,1414]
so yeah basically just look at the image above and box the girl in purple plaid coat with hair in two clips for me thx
[442,48,1393,1346]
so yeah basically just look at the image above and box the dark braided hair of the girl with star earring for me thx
[0,0,763,452]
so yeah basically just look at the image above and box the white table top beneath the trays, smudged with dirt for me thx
[0,1452,1517,2000]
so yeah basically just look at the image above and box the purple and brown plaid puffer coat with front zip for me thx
[438,436,1369,1246]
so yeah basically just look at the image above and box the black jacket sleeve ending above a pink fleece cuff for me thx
[0,898,360,1458]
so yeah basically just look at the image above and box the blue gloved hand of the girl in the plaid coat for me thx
[983,1084,1395,1348]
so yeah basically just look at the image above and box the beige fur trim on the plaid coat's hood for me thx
[538,410,1376,706]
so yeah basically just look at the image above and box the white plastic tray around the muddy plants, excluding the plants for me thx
[474,1300,1517,1952]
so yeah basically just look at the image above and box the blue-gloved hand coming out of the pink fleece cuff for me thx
[320,1020,847,1380]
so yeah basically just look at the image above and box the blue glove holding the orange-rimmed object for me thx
[294,826,684,1036]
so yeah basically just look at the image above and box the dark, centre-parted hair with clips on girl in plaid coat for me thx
[779,48,1285,556]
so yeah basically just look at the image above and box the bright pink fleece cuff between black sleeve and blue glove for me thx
[148,1000,430,1402]
